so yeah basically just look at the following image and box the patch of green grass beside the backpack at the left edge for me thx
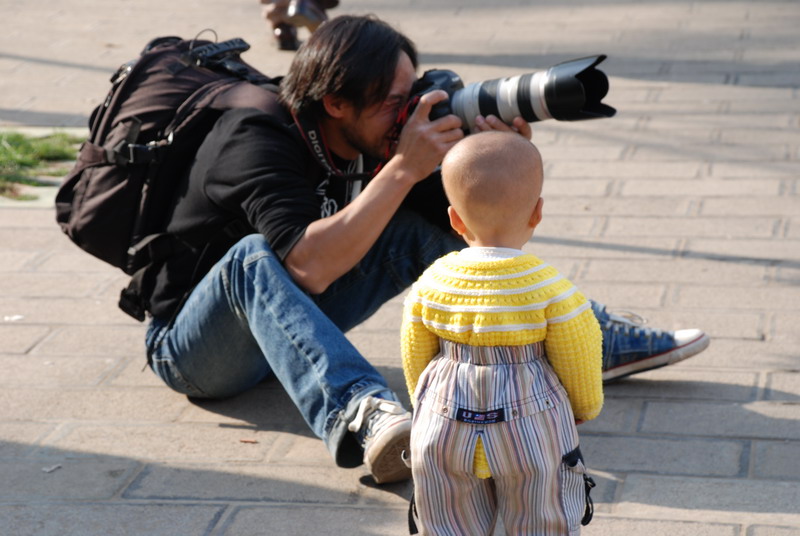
[0,132,83,199]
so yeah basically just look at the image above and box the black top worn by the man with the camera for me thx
[150,109,374,316]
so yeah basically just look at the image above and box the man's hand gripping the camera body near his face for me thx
[394,90,464,181]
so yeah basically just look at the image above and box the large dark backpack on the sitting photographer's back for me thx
[56,37,285,321]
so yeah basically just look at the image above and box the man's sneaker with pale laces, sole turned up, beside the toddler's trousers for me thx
[347,396,411,484]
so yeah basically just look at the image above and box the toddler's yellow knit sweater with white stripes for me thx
[401,250,603,476]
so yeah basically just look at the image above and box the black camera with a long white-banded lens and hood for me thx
[401,55,617,133]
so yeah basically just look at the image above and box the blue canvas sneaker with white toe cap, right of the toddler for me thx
[592,302,711,382]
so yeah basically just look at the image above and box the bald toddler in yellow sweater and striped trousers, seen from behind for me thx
[402,132,603,536]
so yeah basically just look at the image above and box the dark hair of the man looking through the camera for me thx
[280,15,417,114]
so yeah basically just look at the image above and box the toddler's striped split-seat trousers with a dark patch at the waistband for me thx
[411,339,587,536]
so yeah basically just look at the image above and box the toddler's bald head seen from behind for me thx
[442,131,543,240]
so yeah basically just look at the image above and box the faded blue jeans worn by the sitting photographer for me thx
[147,210,464,467]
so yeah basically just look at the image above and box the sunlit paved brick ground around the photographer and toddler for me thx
[0,0,800,536]
